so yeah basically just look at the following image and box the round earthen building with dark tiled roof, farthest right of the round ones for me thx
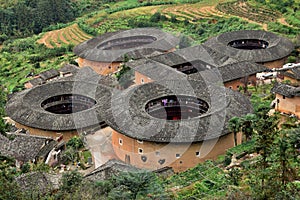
[204,30,294,69]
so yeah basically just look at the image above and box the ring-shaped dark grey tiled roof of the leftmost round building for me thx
[6,70,111,131]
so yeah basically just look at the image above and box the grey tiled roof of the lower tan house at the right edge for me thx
[271,83,300,98]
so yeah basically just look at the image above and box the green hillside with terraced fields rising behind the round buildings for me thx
[0,0,299,92]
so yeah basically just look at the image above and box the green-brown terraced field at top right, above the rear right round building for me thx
[216,0,281,24]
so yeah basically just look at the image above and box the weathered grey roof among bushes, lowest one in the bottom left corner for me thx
[15,172,61,193]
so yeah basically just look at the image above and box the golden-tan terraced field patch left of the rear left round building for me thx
[37,24,92,48]
